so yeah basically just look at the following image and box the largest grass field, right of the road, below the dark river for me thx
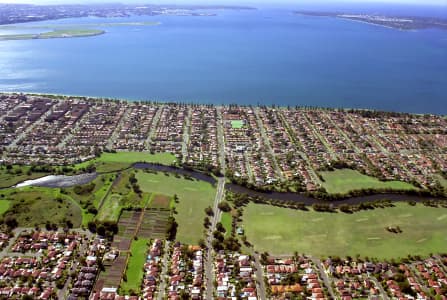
[243,203,447,258]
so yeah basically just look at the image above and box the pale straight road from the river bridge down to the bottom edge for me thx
[204,177,225,300]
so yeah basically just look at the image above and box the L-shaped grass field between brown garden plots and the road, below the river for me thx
[136,172,216,244]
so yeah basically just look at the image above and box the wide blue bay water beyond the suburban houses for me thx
[0,9,447,114]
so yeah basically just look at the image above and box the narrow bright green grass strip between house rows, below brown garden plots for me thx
[120,239,149,294]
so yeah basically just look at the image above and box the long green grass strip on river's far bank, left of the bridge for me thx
[75,152,176,172]
